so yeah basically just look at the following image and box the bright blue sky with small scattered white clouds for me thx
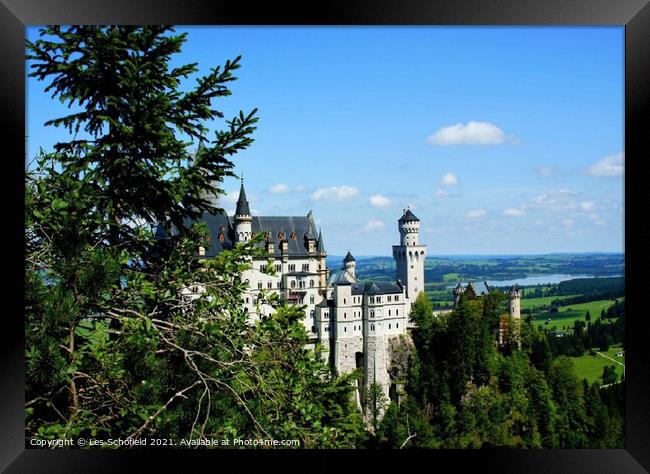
[27,26,624,256]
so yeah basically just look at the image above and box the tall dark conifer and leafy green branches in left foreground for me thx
[25,26,366,447]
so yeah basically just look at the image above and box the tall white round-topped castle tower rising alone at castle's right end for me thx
[393,209,427,302]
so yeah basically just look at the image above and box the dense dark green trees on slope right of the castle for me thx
[378,288,623,448]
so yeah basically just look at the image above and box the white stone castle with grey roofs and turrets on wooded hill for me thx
[177,180,518,406]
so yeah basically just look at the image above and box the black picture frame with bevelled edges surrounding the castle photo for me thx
[0,0,650,474]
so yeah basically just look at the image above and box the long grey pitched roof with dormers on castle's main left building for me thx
[178,213,316,257]
